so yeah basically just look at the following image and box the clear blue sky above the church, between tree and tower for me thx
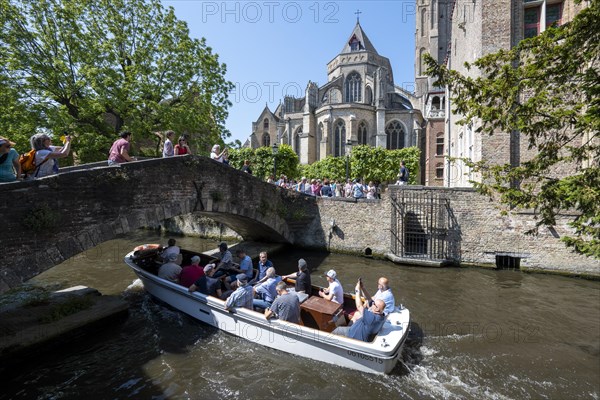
[163,0,415,142]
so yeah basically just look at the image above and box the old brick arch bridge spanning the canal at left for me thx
[0,156,319,292]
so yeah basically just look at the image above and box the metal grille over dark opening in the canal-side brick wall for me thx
[391,190,458,261]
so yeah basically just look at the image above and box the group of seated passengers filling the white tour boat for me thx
[158,239,395,341]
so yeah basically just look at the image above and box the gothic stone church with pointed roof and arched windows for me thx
[246,21,424,164]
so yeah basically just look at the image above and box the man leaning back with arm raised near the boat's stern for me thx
[332,280,385,342]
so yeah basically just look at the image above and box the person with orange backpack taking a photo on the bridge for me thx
[21,133,71,179]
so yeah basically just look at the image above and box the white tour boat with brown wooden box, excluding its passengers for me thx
[125,245,410,373]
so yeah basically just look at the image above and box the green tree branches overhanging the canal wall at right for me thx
[426,0,600,258]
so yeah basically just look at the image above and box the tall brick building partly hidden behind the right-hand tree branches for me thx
[415,0,585,187]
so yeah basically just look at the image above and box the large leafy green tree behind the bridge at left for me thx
[0,0,231,162]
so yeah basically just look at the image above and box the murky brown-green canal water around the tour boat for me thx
[0,232,600,400]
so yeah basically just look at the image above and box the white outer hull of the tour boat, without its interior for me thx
[125,252,410,374]
